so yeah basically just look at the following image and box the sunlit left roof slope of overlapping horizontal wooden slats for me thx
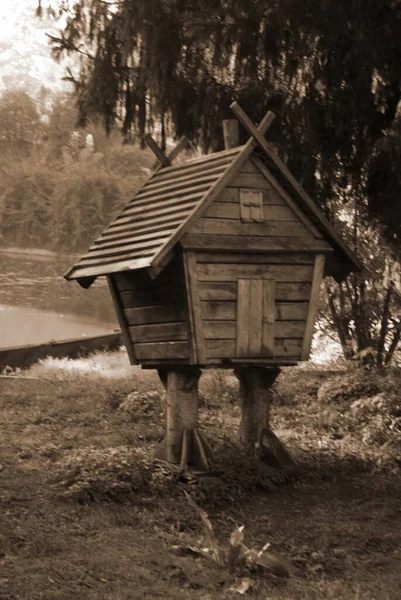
[65,146,243,279]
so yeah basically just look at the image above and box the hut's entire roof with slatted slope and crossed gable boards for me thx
[64,103,363,287]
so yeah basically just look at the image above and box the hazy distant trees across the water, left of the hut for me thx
[0,92,153,252]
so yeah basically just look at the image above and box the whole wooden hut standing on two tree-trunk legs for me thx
[65,103,362,468]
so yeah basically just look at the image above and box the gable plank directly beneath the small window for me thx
[190,217,312,239]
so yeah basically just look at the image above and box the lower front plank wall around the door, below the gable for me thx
[196,252,315,362]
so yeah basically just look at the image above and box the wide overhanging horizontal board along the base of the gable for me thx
[180,233,332,253]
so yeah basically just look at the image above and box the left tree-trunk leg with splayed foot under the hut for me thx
[156,367,212,469]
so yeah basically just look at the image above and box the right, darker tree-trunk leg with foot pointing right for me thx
[234,367,296,469]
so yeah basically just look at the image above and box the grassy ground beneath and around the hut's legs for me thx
[0,354,401,600]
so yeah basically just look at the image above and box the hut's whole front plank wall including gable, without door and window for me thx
[183,161,330,363]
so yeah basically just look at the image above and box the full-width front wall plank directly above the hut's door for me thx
[197,263,313,282]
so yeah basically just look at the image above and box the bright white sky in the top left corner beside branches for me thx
[0,0,73,97]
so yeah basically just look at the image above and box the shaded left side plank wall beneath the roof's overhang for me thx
[115,257,190,364]
